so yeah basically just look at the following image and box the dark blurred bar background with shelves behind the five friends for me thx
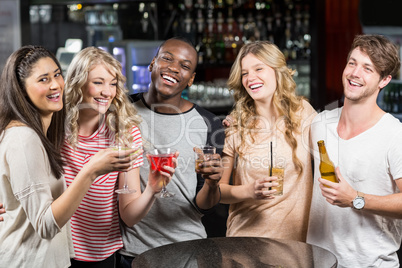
[0,0,402,121]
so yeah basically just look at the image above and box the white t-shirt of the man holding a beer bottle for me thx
[307,108,402,267]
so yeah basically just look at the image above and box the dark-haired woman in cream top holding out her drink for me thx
[0,46,135,267]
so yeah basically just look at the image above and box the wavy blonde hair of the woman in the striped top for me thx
[65,47,141,147]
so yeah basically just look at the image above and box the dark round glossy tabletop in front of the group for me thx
[132,237,337,268]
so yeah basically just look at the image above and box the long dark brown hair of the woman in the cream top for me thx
[0,45,65,178]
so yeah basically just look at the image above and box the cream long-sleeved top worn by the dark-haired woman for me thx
[0,126,73,268]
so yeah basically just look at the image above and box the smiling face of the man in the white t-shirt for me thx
[342,48,389,102]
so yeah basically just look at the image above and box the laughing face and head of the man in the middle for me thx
[150,39,197,98]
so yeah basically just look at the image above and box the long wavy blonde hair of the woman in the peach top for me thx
[226,41,303,175]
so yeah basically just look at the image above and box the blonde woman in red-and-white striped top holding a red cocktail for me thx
[62,47,174,267]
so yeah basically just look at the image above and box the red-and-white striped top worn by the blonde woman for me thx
[62,122,143,262]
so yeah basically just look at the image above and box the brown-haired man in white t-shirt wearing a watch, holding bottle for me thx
[307,35,402,267]
